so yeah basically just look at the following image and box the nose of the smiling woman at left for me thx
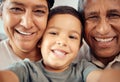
[21,12,34,29]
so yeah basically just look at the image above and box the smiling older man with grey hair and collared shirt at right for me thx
[78,0,120,68]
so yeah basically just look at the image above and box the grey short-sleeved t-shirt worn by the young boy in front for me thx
[9,60,99,82]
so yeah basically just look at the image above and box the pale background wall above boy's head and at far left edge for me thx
[0,0,78,33]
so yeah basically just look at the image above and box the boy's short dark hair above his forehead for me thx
[48,6,83,42]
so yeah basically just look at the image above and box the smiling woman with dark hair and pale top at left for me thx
[0,0,54,69]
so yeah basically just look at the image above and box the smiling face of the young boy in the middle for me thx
[41,14,82,71]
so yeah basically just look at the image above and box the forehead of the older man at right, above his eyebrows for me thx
[84,0,120,10]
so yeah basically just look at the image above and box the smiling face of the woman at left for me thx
[2,0,48,52]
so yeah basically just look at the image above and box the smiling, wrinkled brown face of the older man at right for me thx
[84,0,120,57]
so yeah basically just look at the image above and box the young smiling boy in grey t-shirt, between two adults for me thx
[0,6,101,82]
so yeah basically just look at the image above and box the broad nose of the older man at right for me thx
[96,18,111,35]
